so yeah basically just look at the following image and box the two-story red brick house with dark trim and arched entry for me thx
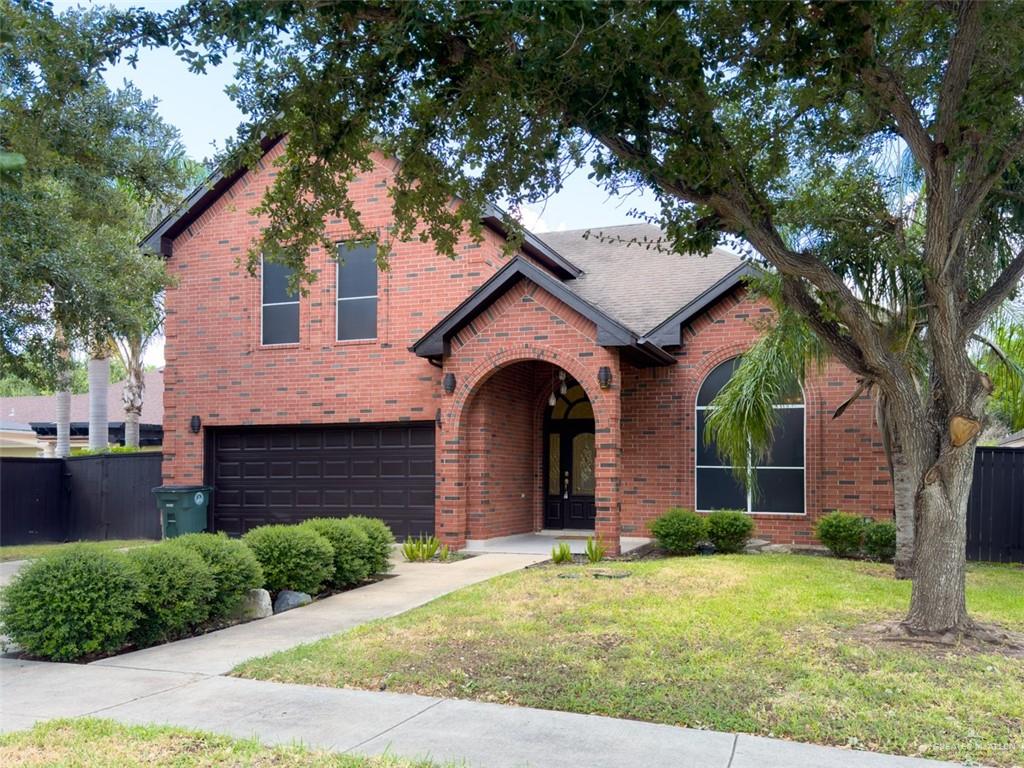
[146,142,892,551]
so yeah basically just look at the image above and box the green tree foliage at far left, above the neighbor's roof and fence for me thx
[0,0,184,388]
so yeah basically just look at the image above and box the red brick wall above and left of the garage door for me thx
[164,145,505,483]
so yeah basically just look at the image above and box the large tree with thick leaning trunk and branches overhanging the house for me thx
[150,0,1024,634]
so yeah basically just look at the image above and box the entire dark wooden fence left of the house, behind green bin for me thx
[0,453,164,545]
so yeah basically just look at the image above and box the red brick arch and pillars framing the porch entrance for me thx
[436,342,622,552]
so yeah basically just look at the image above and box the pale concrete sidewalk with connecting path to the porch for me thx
[0,554,951,768]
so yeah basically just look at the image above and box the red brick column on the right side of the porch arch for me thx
[592,366,623,555]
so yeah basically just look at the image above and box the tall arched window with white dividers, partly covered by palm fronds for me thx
[695,357,804,514]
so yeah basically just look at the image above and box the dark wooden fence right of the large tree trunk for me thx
[967,447,1024,562]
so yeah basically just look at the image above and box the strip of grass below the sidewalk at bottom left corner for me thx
[0,720,431,768]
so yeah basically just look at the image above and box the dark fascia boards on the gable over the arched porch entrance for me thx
[410,256,676,366]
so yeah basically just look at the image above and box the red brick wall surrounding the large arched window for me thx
[622,291,893,543]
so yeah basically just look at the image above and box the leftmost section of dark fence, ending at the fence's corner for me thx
[0,458,68,545]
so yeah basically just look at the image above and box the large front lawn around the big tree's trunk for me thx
[234,555,1024,766]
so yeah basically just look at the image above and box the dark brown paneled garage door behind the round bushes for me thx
[207,424,434,541]
